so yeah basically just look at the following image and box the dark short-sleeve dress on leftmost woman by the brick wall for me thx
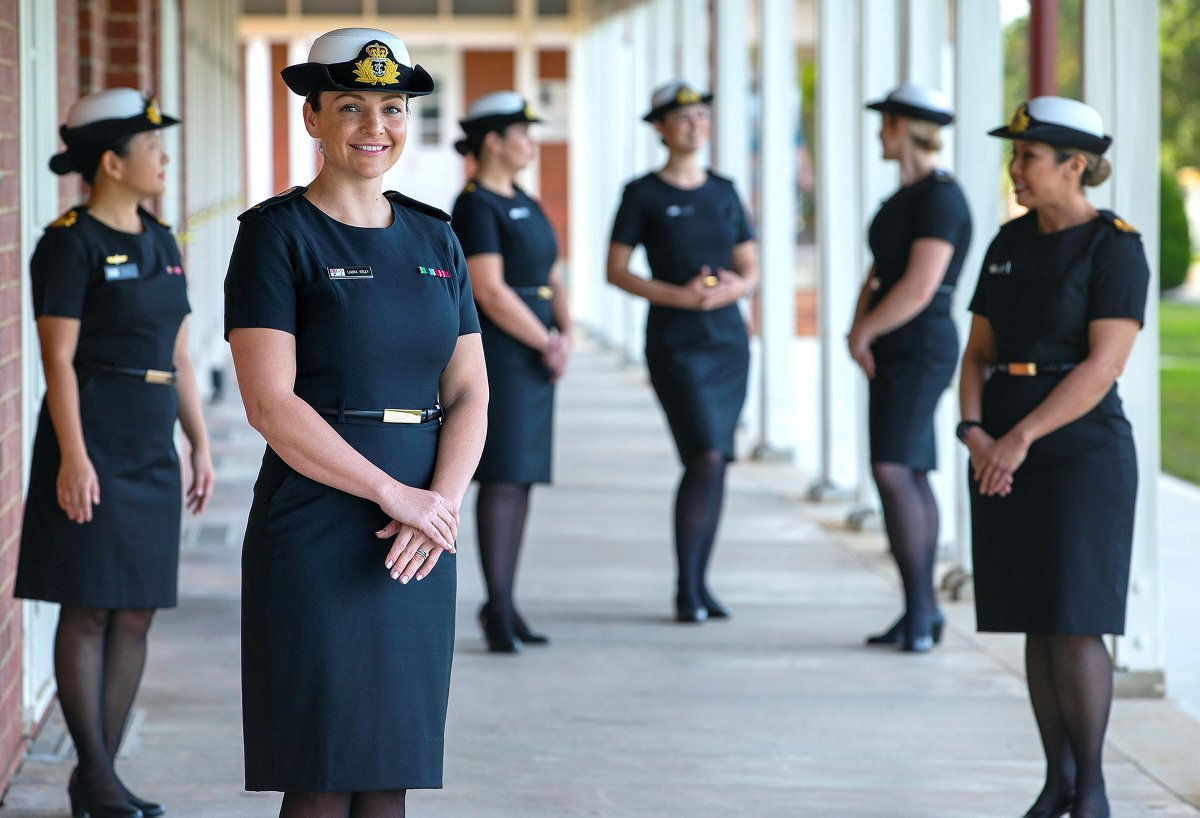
[13,206,190,608]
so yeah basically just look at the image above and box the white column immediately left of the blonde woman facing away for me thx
[812,0,864,498]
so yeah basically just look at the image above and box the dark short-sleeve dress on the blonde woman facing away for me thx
[868,170,971,471]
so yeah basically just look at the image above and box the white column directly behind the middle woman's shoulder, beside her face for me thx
[713,0,750,196]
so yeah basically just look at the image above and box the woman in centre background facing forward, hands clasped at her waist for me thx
[608,83,758,622]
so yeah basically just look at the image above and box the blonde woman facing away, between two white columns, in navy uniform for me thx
[847,83,971,652]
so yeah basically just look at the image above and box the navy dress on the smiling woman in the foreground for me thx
[226,188,479,792]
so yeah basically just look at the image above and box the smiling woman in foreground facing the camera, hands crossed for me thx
[226,29,487,817]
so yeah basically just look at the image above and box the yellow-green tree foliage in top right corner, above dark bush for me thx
[1158,0,1200,170]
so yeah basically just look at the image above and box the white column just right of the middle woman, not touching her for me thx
[758,0,799,455]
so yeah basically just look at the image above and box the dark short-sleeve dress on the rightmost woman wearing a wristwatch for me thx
[970,211,1150,634]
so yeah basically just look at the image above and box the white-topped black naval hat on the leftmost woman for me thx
[50,88,179,176]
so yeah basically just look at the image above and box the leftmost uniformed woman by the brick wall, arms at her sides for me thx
[14,88,214,818]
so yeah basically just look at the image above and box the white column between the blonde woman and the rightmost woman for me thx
[938,0,1006,576]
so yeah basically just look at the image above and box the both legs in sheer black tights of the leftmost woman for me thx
[54,606,155,805]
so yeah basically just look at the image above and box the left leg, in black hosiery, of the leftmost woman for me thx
[54,606,125,806]
